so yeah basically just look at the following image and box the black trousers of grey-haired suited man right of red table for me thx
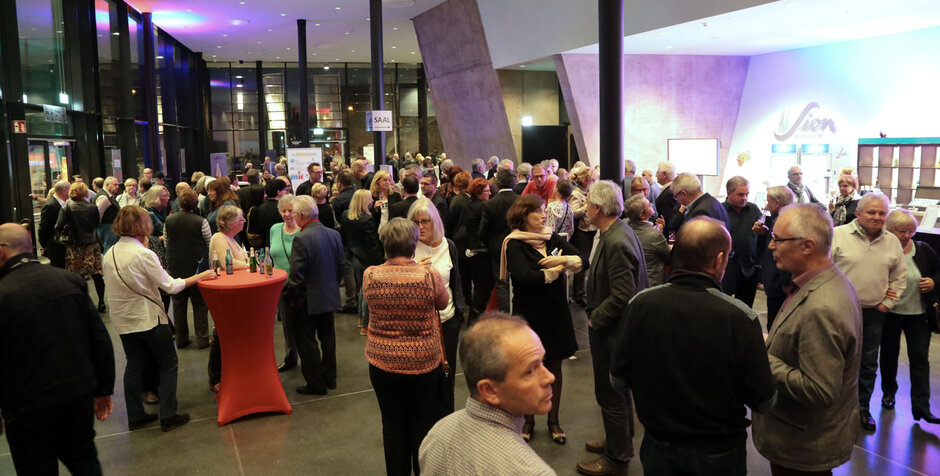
[291,309,336,392]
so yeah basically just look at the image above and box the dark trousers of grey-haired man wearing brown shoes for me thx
[588,326,635,465]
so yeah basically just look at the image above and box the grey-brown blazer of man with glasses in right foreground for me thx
[753,265,862,471]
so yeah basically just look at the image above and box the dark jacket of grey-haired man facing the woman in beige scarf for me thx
[586,220,649,333]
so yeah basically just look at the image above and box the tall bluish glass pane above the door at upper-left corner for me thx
[16,0,70,107]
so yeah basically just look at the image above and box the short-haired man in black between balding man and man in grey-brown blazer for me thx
[721,176,763,307]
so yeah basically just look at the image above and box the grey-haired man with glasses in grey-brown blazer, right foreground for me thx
[753,204,862,474]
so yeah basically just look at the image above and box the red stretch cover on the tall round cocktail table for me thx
[199,269,291,426]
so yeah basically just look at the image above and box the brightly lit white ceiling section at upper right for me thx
[568,0,940,56]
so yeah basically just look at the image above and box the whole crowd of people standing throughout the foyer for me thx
[0,153,940,475]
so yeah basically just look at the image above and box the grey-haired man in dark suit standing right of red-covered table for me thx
[283,195,343,395]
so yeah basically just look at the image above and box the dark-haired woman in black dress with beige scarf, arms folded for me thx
[499,195,581,445]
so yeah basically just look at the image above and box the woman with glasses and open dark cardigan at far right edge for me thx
[880,210,940,424]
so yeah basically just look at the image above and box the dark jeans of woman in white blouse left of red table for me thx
[121,324,178,422]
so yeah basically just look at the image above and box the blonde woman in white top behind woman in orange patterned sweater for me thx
[408,198,464,413]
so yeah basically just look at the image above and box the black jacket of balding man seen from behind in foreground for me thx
[610,273,776,453]
